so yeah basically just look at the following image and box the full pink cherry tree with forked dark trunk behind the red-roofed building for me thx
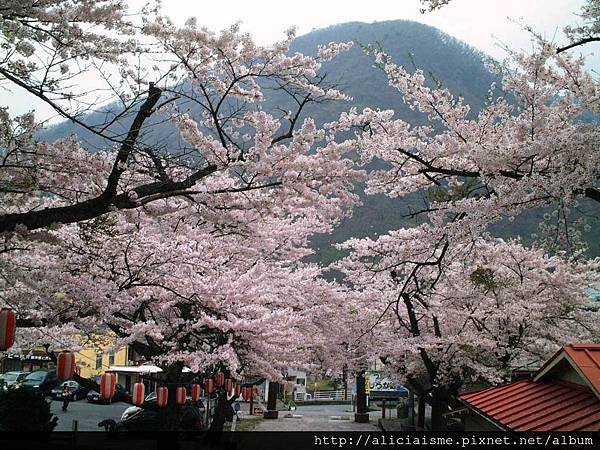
[338,232,599,429]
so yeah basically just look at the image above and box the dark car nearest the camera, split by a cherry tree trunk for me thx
[98,405,203,433]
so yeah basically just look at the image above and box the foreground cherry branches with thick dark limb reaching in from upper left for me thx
[0,0,349,231]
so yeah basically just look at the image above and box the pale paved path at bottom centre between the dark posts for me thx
[255,405,381,431]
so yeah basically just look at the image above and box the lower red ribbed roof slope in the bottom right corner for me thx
[460,382,600,431]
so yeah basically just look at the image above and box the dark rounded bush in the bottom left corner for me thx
[0,388,58,433]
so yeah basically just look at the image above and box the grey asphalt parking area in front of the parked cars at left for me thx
[50,399,131,431]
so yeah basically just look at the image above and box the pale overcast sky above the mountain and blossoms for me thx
[1,0,600,119]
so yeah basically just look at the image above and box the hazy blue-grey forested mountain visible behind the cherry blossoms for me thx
[41,21,600,262]
